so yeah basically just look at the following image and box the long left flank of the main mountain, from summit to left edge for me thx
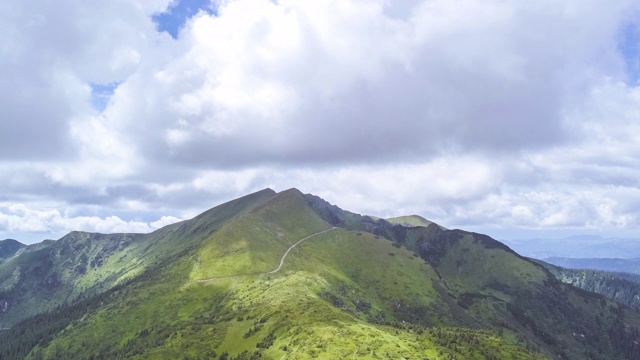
[0,189,275,328]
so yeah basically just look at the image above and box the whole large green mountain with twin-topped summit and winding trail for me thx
[0,189,640,359]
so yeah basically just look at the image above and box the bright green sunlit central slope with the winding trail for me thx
[17,191,538,359]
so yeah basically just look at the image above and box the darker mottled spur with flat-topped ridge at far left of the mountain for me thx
[0,232,149,327]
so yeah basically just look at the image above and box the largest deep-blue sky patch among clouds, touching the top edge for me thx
[152,0,215,39]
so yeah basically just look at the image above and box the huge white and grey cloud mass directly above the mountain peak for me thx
[106,0,628,167]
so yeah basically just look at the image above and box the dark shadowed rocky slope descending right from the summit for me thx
[307,196,640,359]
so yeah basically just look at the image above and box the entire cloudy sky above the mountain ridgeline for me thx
[0,0,640,243]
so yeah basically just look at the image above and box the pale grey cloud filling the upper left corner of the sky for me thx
[0,0,167,160]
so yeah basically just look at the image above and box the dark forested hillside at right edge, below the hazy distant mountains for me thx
[537,260,640,309]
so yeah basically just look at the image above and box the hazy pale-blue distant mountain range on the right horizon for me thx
[502,235,640,259]
